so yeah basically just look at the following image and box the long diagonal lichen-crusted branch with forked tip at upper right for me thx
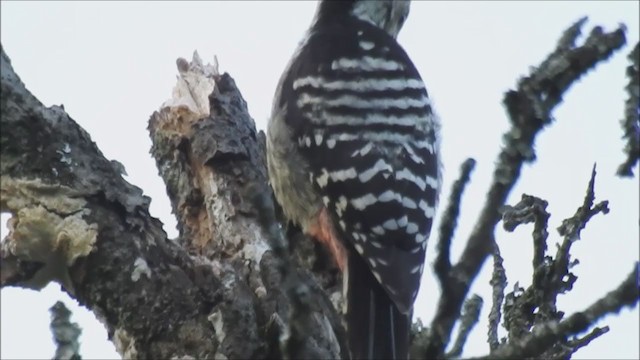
[425,19,626,358]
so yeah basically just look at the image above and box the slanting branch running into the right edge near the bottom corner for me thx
[478,263,640,359]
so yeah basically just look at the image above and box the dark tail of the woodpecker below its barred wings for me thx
[345,251,411,359]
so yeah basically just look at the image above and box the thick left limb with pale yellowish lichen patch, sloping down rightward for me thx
[0,44,221,358]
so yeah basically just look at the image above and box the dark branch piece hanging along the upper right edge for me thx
[617,42,640,177]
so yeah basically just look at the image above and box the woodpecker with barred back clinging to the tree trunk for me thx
[267,0,441,359]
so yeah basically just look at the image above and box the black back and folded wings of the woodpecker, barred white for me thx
[284,24,439,312]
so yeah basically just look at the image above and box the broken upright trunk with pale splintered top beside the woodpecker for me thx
[149,53,348,358]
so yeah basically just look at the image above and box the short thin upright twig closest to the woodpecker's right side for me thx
[434,158,476,287]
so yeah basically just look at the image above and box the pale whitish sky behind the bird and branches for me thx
[0,1,640,359]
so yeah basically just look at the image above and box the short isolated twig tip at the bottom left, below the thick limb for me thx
[49,301,82,360]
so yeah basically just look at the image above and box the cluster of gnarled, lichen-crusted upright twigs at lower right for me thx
[489,165,624,359]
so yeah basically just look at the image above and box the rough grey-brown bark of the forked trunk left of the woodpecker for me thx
[0,46,346,359]
